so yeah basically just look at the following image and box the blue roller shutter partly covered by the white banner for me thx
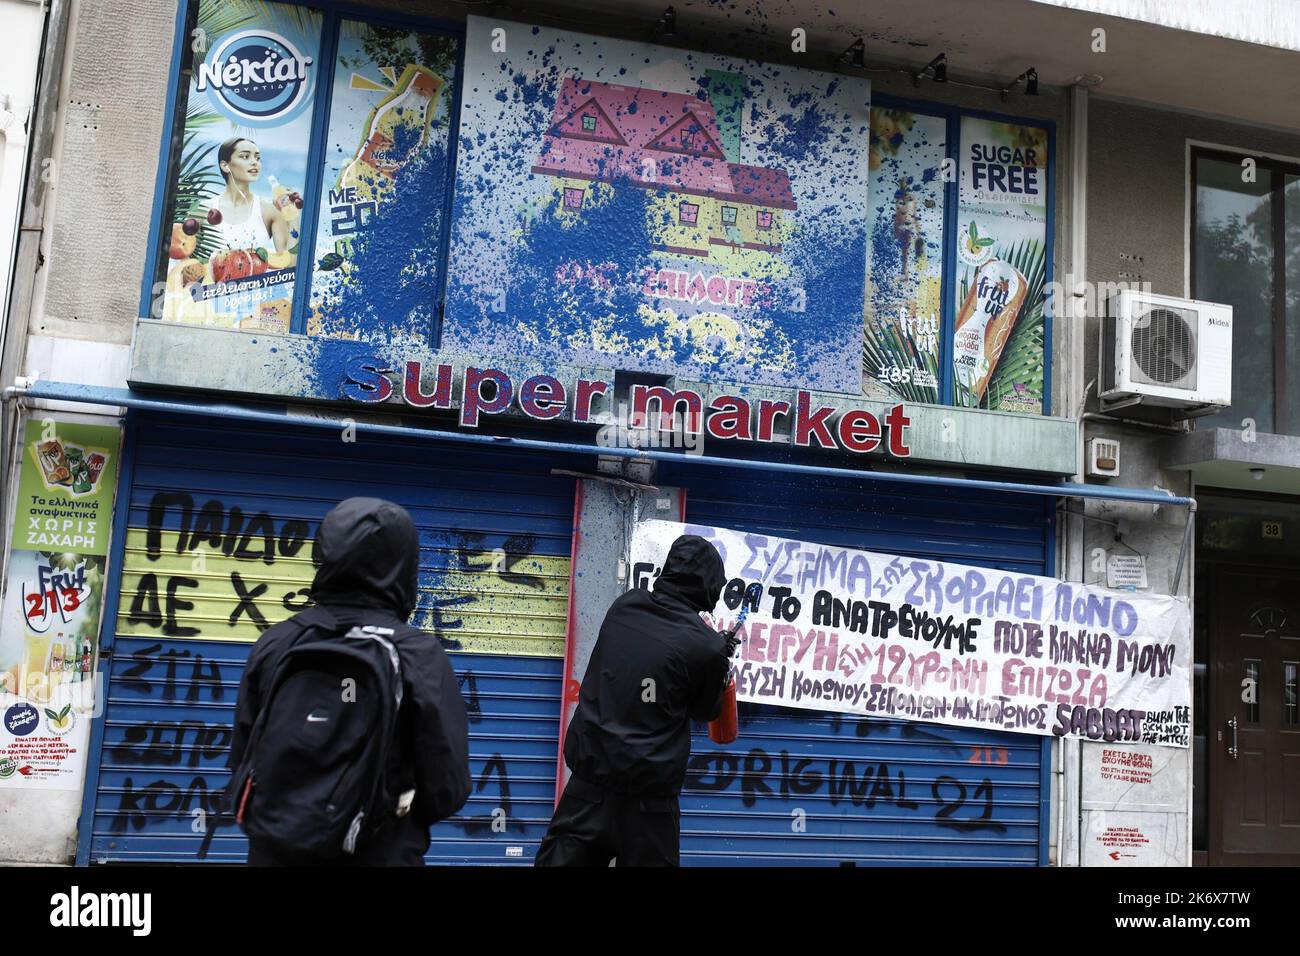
[660,466,1053,866]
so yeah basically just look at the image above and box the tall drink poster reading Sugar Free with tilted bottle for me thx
[953,117,1050,415]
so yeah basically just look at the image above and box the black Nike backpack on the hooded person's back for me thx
[230,627,402,861]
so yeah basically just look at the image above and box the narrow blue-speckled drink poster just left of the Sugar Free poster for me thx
[862,107,948,402]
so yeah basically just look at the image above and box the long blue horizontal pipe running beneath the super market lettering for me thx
[17,381,1193,507]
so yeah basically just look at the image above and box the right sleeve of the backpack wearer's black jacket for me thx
[402,633,469,825]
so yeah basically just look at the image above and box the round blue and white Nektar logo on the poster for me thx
[195,30,312,126]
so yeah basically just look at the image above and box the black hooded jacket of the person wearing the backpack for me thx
[229,498,469,864]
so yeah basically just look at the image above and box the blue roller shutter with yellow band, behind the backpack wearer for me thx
[78,415,580,865]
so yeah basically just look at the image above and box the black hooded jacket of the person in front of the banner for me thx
[564,535,731,796]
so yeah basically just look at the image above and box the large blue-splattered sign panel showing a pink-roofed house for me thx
[443,18,870,393]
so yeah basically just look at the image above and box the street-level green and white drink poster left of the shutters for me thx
[0,419,120,790]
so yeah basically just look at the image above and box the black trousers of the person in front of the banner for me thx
[533,777,681,866]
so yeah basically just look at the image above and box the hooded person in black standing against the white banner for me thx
[537,535,731,866]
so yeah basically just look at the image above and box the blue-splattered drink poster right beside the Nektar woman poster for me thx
[307,21,459,343]
